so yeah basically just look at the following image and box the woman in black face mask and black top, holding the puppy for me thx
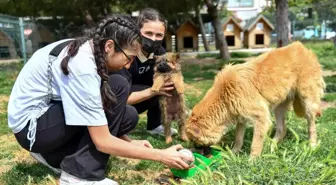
[118,8,177,135]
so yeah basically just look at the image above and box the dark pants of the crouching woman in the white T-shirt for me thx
[15,75,138,180]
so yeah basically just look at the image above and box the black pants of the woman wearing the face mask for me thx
[131,85,161,130]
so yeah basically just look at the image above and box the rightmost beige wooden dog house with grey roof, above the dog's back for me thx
[244,15,274,48]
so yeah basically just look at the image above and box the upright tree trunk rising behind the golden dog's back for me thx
[275,0,289,48]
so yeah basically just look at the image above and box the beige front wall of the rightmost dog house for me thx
[244,19,272,48]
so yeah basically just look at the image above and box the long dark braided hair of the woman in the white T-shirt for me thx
[61,14,141,113]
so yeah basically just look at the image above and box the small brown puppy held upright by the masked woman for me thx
[152,53,187,143]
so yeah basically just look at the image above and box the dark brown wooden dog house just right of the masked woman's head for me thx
[176,20,199,52]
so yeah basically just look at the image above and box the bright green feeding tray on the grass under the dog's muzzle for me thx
[170,149,221,178]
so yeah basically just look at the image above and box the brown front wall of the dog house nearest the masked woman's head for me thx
[176,22,198,52]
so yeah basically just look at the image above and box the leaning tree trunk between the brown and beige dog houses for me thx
[204,0,230,61]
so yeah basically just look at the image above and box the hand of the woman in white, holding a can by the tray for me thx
[160,145,193,170]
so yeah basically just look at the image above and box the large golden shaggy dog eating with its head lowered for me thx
[185,42,325,158]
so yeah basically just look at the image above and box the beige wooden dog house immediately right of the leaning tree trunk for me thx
[223,17,243,49]
